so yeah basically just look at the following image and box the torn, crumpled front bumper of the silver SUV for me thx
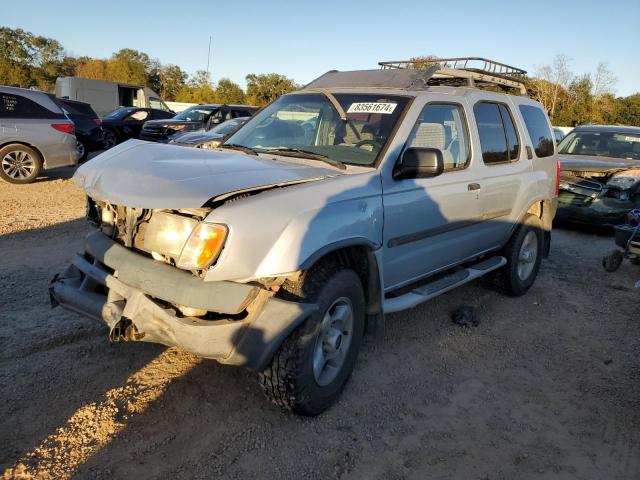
[49,232,317,370]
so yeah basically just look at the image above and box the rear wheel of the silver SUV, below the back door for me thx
[496,215,544,297]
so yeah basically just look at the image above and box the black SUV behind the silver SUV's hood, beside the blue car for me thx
[140,104,258,143]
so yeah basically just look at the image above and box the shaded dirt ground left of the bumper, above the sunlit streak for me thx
[0,219,162,469]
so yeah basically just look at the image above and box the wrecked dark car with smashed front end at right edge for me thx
[557,125,640,226]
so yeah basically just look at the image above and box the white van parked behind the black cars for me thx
[56,77,171,116]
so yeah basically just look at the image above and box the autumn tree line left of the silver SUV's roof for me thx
[0,27,299,106]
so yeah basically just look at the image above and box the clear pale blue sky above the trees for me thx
[0,0,640,95]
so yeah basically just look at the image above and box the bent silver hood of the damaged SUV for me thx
[73,140,340,208]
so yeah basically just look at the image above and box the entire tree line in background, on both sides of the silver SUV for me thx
[0,27,640,126]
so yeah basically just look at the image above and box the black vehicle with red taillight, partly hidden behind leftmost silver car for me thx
[56,98,104,162]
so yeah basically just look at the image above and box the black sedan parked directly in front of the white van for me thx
[102,107,175,148]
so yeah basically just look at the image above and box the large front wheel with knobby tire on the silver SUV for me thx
[260,264,365,416]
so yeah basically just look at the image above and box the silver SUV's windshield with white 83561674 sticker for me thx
[225,93,409,166]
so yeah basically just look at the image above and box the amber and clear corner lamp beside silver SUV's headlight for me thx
[176,223,227,270]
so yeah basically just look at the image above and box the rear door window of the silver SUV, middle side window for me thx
[473,102,520,164]
